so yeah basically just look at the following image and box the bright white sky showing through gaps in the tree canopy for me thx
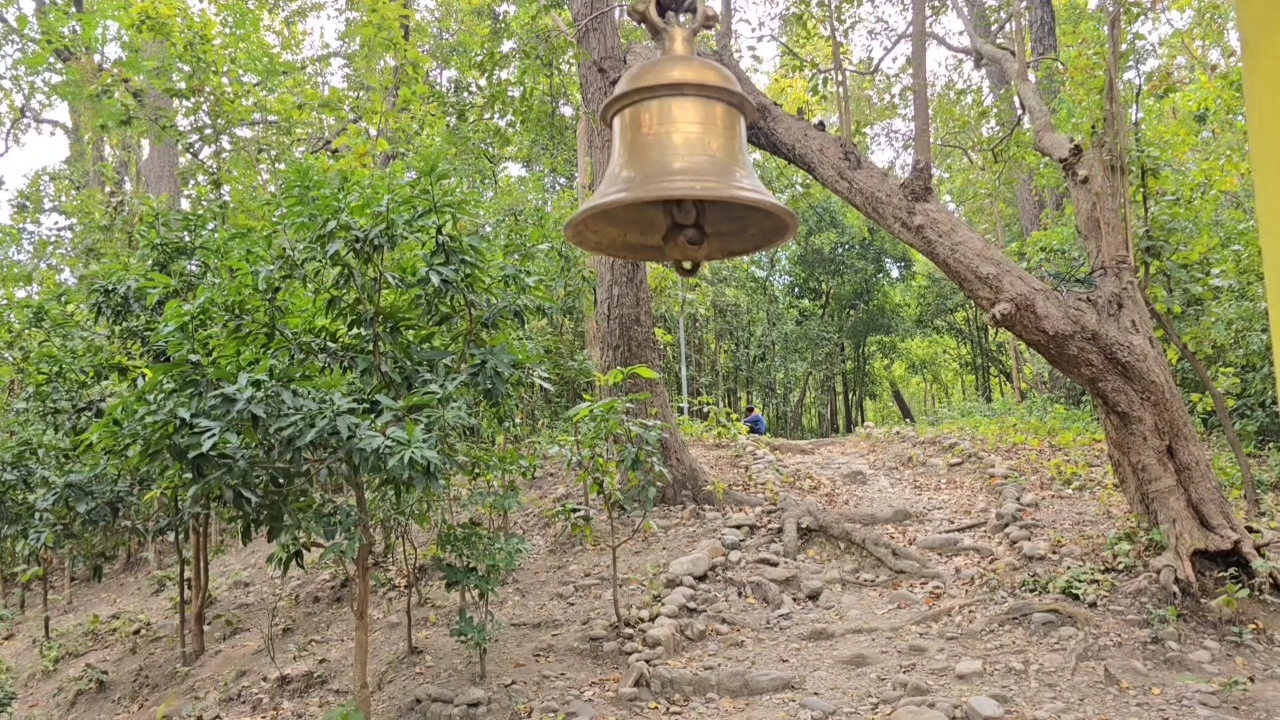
[0,0,946,223]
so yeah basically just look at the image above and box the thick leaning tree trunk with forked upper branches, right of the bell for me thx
[717,0,1280,588]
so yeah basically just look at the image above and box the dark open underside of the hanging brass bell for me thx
[564,193,800,263]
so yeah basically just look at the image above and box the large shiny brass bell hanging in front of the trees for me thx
[564,3,800,275]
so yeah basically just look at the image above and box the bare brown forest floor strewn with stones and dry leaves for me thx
[0,429,1280,720]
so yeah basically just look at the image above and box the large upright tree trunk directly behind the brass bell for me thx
[570,0,709,502]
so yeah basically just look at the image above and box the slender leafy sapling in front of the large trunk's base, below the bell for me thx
[562,365,668,629]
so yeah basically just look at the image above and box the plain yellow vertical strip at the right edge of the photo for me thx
[1235,0,1280,393]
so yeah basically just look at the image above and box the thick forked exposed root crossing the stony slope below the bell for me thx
[782,497,942,578]
